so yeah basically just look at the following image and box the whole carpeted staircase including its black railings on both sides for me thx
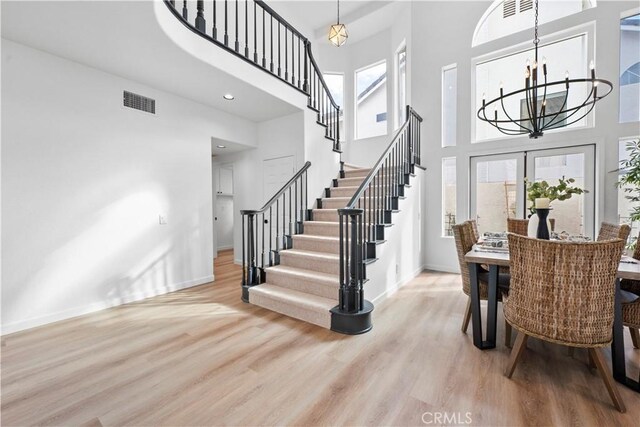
[241,106,422,334]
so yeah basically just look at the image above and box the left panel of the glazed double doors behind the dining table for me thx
[469,152,525,234]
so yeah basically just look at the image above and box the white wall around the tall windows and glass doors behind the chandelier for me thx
[411,1,639,271]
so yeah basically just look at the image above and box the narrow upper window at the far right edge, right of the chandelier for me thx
[620,14,640,123]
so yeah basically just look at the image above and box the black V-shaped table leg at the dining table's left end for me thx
[469,263,498,350]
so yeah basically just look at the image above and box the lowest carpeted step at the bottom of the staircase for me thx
[249,282,336,329]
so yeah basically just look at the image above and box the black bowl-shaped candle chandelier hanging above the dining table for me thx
[478,0,613,139]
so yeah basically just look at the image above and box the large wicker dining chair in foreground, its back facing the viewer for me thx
[503,234,625,412]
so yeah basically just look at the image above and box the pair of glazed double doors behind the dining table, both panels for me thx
[469,145,595,238]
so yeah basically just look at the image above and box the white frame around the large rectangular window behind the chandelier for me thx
[470,21,597,145]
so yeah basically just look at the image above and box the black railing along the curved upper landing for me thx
[164,0,341,152]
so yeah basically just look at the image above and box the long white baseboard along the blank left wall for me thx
[0,274,215,336]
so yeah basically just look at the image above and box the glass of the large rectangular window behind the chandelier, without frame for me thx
[474,33,592,142]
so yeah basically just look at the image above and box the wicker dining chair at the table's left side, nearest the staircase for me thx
[453,221,511,347]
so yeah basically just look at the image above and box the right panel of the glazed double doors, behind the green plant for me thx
[526,145,596,238]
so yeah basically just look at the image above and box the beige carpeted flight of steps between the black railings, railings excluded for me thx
[249,168,371,329]
